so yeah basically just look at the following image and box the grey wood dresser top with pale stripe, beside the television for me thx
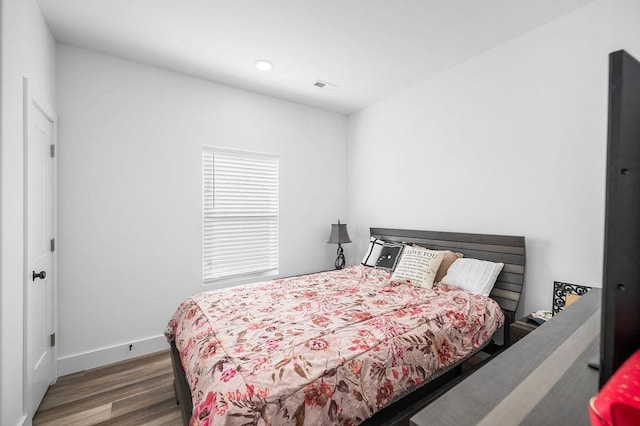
[411,288,602,426]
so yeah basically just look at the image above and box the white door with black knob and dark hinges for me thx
[25,81,56,416]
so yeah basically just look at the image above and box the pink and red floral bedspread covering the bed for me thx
[166,266,504,426]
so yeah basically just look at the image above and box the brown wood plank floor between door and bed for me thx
[33,351,182,426]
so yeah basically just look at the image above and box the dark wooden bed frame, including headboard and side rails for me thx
[170,228,525,425]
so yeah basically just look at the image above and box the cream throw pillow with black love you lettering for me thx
[391,247,444,288]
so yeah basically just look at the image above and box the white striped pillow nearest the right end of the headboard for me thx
[440,257,504,296]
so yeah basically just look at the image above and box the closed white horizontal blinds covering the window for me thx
[202,148,279,281]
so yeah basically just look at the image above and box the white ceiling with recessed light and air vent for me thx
[38,0,593,114]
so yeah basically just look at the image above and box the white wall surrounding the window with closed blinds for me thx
[57,45,346,373]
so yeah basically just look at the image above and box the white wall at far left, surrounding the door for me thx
[0,0,56,425]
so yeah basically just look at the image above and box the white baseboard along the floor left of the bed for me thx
[58,335,169,376]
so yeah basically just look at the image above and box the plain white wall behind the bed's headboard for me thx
[348,0,640,312]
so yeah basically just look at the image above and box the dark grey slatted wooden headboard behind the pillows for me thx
[370,228,525,330]
